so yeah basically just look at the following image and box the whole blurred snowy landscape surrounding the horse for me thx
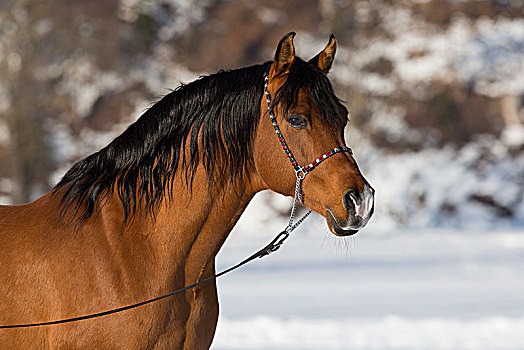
[0,0,524,349]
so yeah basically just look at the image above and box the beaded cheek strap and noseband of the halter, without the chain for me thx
[264,72,353,179]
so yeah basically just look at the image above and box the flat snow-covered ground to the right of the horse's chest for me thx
[212,200,524,350]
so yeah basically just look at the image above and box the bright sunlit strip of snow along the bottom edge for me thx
[214,316,524,350]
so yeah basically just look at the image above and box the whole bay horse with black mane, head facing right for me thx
[0,33,374,349]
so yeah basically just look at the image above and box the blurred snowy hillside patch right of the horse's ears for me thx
[332,6,524,98]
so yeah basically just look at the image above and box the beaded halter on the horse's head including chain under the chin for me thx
[264,72,353,235]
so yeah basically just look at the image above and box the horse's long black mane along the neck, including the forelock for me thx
[55,57,346,224]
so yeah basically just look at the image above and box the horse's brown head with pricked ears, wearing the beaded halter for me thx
[253,33,375,236]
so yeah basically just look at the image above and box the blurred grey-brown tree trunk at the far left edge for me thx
[0,1,51,203]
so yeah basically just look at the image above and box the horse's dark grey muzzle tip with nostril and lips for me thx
[326,185,375,236]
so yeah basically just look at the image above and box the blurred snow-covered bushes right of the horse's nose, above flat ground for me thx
[346,130,524,229]
